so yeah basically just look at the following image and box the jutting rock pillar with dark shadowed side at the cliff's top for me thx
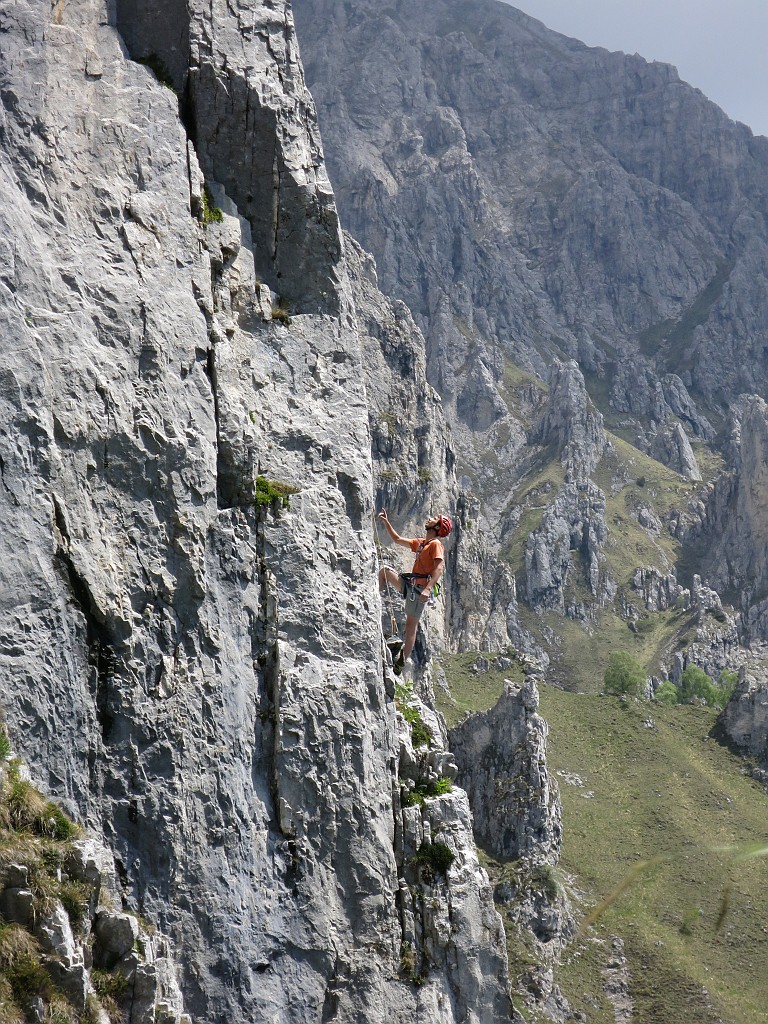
[116,0,342,312]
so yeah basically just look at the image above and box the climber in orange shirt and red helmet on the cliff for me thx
[379,509,454,676]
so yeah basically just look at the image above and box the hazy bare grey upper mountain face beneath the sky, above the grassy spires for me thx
[294,0,768,436]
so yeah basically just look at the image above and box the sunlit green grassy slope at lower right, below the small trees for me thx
[441,655,768,1024]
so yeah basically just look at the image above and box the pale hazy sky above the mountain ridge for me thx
[505,0,768,135]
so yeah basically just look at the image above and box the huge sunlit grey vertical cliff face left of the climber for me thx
[0,0,518,1024]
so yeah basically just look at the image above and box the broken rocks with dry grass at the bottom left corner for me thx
[0,753,190,1024]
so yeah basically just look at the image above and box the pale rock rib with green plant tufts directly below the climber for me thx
[395,687,512,1021]
